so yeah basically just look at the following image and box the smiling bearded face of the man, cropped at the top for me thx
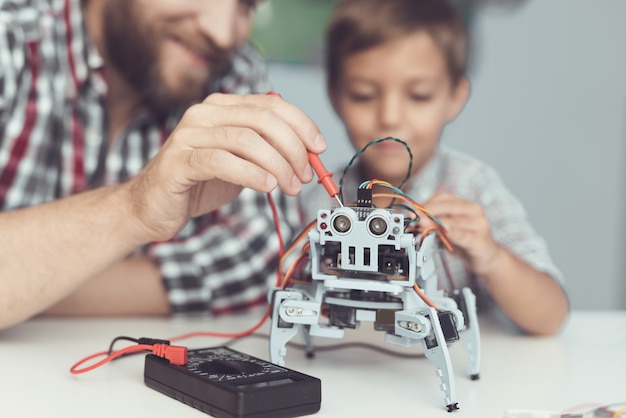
[103,0,257,111]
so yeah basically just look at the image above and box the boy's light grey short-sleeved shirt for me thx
[302,147,563,306]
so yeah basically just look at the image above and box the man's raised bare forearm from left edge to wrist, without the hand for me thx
[0,184,147,328]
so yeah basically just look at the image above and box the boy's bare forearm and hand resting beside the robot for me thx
[425,192,569,335]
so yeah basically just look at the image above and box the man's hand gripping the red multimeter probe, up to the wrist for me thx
[125,94,326,241]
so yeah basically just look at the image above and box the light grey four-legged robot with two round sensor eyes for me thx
[269,196,480,412]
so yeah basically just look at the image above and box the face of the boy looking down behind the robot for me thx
[331,32,469,185]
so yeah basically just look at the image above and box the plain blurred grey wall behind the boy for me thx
[270,0,626,309]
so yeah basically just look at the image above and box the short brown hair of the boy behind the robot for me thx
[326,0,468,90]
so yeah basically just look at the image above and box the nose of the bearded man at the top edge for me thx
[198,0,249,49]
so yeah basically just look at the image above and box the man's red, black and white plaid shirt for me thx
[0,0,298,313]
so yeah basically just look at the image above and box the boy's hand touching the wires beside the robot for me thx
[424,192,502,275]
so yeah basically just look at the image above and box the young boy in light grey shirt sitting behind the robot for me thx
[303,0,569,335]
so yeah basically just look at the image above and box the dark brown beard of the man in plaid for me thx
[103,0,232,117]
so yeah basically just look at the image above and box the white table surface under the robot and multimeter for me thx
[0,311,626,418]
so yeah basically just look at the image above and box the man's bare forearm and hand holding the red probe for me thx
[0,94,326,328]
